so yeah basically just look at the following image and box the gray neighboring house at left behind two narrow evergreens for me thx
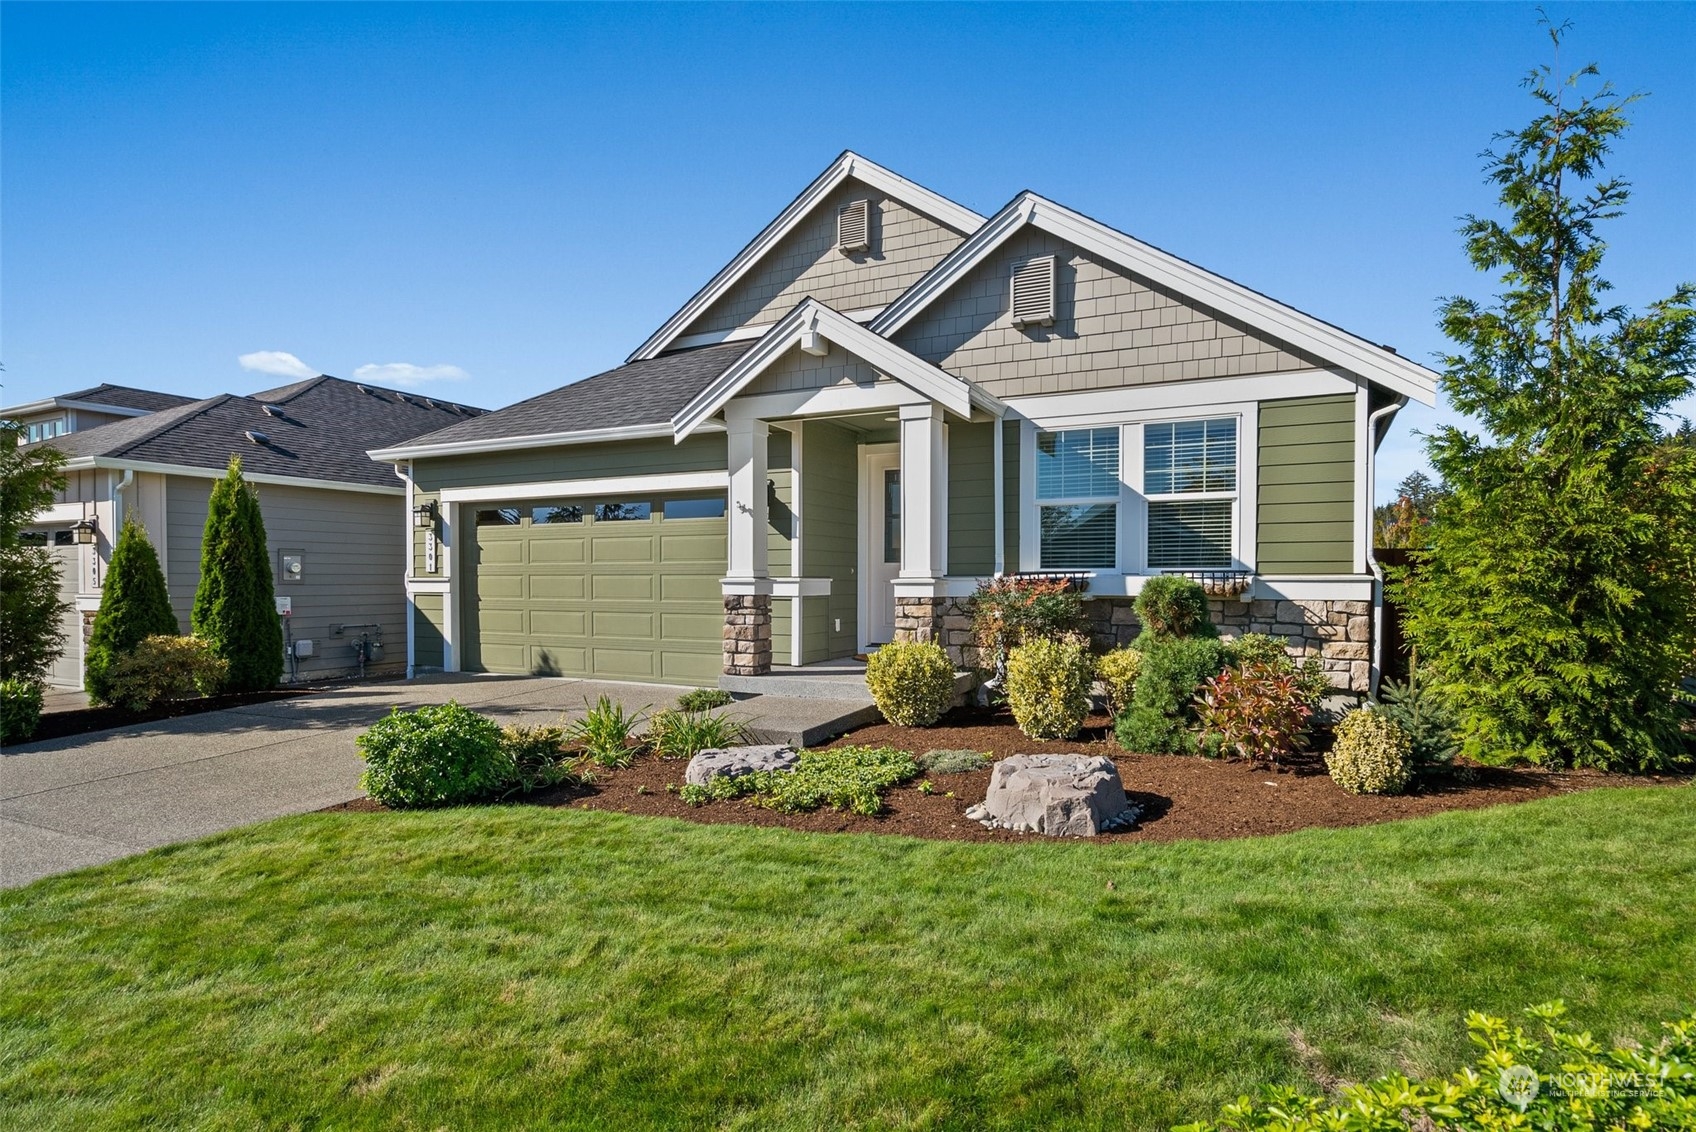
[31,377,482,687]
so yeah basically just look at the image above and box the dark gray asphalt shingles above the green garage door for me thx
[393,341,753,448]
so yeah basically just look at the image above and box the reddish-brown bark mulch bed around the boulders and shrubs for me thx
[320,711,1688,842]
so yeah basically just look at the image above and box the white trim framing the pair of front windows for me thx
[1018,401,1260,579]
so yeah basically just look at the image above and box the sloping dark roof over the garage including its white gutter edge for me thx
[370,341,753,460]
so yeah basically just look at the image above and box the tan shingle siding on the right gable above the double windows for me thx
[895,227,1319,397]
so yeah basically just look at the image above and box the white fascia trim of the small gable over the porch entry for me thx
[672,299,1006,441]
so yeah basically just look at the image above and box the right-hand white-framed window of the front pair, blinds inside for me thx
[1143,417,1236,572]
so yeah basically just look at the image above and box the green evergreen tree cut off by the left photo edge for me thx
[0,421,70,684]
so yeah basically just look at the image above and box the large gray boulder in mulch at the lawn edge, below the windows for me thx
[965,755,1136,837]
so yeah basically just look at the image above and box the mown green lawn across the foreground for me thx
[0,787,1696,1130]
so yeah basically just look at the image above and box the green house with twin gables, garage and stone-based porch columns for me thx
[371,153,1437,692]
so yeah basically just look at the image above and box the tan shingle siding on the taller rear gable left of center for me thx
[682,180,963,338]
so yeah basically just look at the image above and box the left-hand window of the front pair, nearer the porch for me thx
[1036,426,1119,570]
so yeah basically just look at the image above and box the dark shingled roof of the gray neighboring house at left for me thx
[42,377,482,489]
